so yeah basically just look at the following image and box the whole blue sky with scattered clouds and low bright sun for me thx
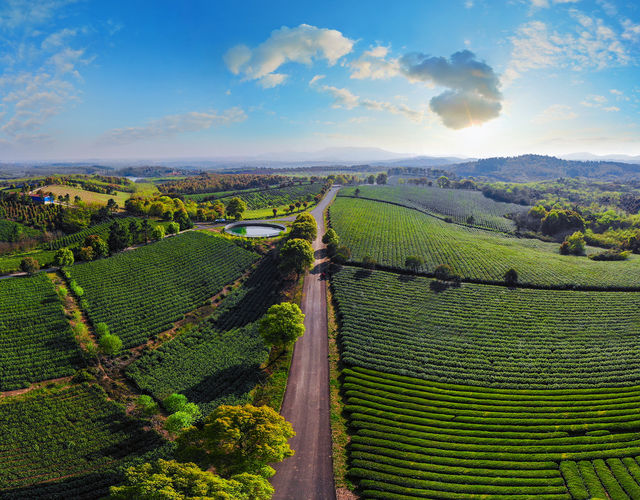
[0,0,640,161]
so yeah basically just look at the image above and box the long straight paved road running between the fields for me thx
[271,188,338,500]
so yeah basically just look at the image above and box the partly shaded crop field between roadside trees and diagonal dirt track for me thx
[127,259,279,414]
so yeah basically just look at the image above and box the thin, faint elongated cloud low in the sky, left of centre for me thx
[100,108,247,144]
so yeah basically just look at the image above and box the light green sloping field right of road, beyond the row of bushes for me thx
[329,198,640,287]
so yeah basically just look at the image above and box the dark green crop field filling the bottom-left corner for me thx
[0,385,168,499]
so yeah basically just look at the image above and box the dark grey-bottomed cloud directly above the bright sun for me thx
[400,50,502,130]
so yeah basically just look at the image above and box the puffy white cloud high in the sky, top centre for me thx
[224,24,354,87]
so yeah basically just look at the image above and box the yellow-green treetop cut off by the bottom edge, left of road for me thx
[108,459,274,500]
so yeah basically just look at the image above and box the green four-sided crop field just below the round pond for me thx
[68,231,258,348]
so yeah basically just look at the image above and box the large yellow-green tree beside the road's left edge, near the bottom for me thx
[177,404,295,477]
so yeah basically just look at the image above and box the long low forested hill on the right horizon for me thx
[446,155,640,182]
